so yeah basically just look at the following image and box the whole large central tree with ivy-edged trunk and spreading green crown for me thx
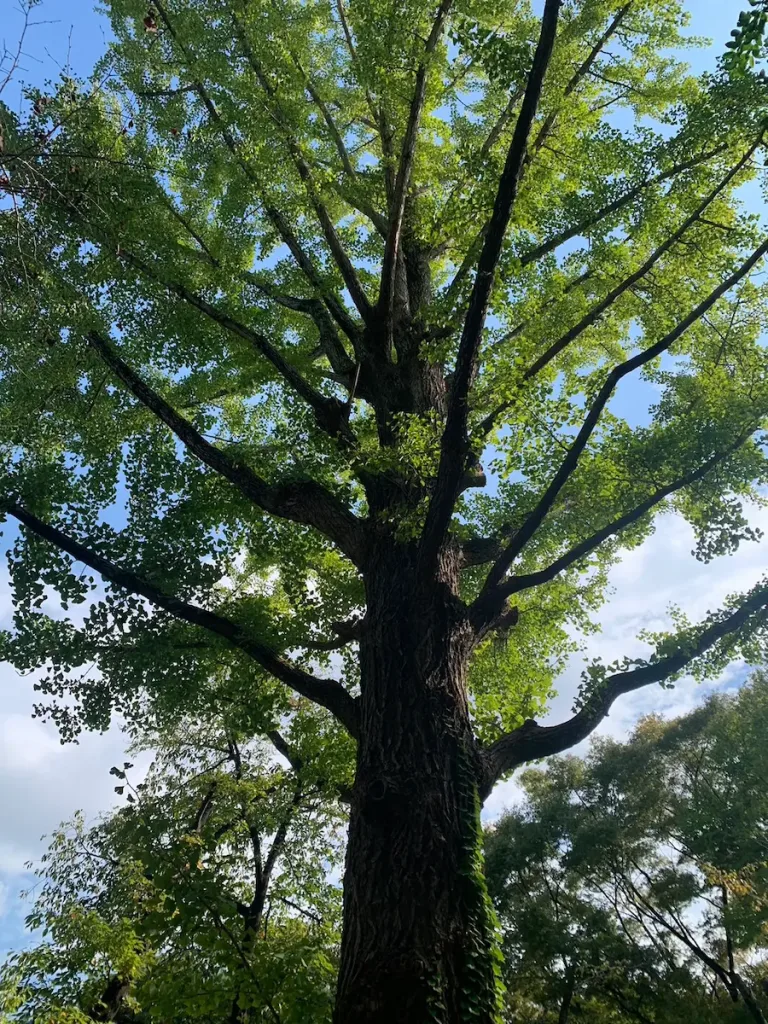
[0,0,768,1024]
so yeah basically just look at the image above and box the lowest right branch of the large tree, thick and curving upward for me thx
[480,584,768,799]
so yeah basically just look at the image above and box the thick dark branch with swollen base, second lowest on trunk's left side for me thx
[88,331,367,565]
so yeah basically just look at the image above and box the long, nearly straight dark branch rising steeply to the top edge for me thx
[421,0,560,570]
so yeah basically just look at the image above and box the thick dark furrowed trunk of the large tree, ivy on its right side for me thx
[334,549,501,1024]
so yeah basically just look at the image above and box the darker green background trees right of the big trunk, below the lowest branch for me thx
[487,673,768,1024]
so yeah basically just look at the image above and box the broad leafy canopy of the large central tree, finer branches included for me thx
[2,2,765,761]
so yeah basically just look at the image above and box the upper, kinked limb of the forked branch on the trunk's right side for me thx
[484,239,768,594]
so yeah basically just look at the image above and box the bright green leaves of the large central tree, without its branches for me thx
[0,0,766,761]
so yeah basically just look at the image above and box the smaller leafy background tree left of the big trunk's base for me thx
[0,720,342,1024]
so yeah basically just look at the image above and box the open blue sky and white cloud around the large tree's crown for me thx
[0,0,768,953]
